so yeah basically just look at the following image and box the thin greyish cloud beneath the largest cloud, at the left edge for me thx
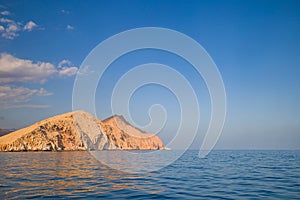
[0,85,52,109]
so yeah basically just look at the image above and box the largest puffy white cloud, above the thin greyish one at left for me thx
[0,53,78,84]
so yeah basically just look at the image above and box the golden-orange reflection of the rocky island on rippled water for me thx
[0,151,159,199]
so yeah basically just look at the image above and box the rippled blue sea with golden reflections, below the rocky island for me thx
[0,150,300,199]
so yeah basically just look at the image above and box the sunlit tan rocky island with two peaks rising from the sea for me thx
[0,111,163,151]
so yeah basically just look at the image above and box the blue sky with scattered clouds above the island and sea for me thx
[0,0,300,149]
